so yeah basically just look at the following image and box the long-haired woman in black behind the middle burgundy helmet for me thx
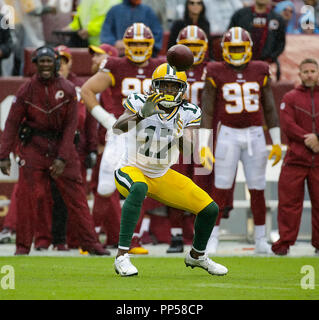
[167,0,212,58]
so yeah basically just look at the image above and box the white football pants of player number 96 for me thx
[214,125,268,190]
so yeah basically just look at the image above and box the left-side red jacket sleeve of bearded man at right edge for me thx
[280,96,307,142]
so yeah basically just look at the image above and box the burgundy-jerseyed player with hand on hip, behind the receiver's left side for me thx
[81,23,164,254]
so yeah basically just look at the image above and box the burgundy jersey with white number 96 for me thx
[207,61,269,128]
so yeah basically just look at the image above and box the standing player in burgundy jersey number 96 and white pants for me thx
[200,27,281,254]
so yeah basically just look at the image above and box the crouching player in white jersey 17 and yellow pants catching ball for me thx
[113,63,228,276]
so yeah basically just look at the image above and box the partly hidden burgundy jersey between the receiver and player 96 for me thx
[186,62,207,107]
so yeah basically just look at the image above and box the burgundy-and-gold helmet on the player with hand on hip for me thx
[123,22,154,63]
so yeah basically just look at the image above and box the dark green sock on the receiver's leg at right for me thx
[193,202,219,252]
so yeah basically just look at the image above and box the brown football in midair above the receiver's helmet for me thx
[166,44,194,71]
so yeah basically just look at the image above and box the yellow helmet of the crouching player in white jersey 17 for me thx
[152,63,187,108]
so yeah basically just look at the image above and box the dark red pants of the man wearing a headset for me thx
[16,167,98,250]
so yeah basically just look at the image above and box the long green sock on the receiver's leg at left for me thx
[119,182,148,248]
